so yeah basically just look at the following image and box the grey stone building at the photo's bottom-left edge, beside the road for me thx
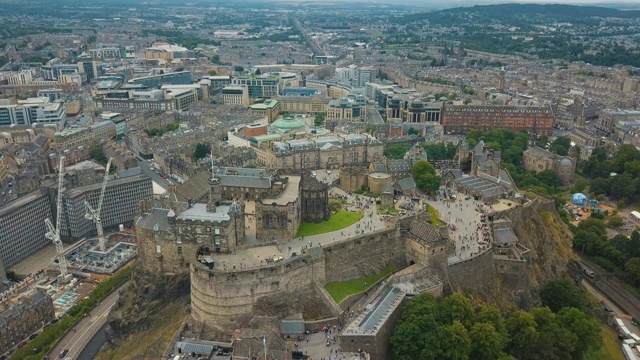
[0,290,55,353]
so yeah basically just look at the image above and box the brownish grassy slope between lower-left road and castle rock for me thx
[95,301,187,360]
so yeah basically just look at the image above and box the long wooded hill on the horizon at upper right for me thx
[396,4,640,26]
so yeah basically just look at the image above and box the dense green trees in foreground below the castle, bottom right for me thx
[391,280,602,360]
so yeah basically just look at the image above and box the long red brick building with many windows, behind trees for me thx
[442,105,554,135]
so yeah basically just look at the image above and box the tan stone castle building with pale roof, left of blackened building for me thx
[256,176,301,241]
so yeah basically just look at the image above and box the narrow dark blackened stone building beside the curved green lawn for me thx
[300,171,331,222]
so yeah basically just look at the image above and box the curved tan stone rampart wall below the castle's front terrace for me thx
[191,228,406,329]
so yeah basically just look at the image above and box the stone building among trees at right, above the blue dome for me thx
[523,146,576,185]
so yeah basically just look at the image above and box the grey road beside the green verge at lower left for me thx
[48,282,128,359]
